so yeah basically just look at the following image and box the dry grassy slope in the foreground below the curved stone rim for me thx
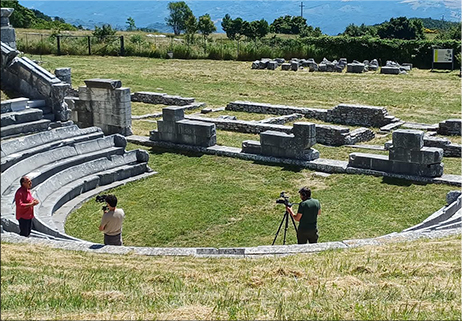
[1,236,461,320]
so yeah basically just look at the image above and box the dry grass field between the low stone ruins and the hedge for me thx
[28,56,461,124]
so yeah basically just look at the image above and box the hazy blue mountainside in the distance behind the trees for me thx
[19,0,461,35]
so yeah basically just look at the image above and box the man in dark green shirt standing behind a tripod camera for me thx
[286,186,321,244]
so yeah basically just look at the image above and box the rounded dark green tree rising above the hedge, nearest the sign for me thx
[377,17,425,40]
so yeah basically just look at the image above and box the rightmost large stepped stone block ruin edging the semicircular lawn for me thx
[348,129,443,177]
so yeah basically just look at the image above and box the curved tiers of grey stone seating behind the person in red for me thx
[0,98,155,239]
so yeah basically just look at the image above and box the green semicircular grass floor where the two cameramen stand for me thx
[66,144,454,247]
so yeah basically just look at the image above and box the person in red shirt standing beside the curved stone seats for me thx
[14,176,39,237]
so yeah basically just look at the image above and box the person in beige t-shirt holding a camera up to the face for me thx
[99,195,125,245]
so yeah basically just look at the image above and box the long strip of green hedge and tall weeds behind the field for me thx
[18,36,461,69]
